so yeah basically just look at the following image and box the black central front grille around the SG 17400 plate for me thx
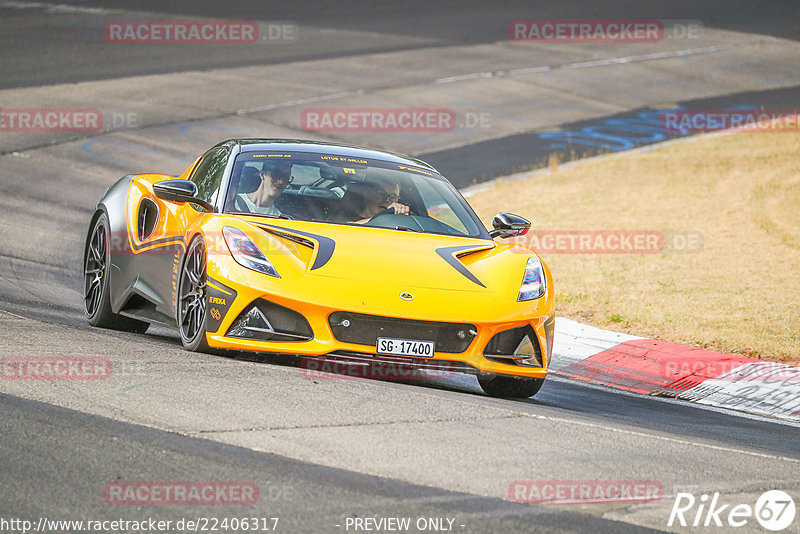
[328,312,477,353]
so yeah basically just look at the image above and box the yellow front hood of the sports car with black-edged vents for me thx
[207,216,552,322]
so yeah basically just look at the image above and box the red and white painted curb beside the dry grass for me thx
[550,317,800,422]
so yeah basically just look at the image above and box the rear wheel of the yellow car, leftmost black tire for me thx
[83,213,150,334]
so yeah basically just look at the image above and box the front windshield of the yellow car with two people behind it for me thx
[224,152,488,238]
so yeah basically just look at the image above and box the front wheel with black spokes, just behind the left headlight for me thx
[176,235,211,352]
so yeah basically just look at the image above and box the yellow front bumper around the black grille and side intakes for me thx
[207,260,554,378]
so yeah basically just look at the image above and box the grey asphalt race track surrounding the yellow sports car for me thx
[0,0,800,533]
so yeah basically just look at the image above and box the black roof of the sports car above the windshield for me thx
[216,138,439,173]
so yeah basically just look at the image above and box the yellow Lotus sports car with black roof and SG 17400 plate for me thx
[84,139,554,397]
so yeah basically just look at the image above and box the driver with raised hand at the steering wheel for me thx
[335,178,410,223]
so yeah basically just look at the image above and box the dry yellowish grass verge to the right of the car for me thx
[469,133,800,365]
